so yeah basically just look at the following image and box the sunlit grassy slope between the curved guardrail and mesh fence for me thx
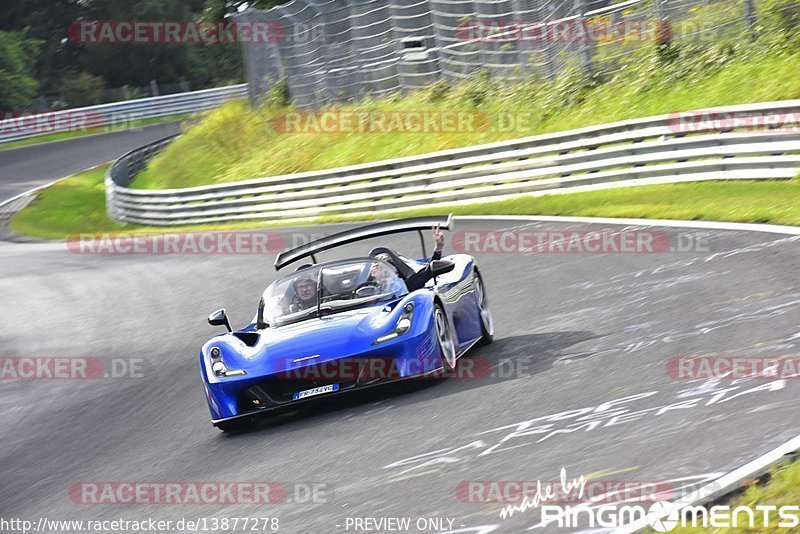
[133,34,800,193]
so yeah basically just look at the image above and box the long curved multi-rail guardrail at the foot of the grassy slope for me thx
[106,100,800,225]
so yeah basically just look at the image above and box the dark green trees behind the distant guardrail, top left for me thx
[0,0,288,109]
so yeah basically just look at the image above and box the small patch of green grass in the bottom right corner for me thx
[660,461,800,534]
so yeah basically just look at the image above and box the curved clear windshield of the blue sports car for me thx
[263,260,408,327]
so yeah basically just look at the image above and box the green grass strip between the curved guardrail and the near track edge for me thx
[11,165,800,239]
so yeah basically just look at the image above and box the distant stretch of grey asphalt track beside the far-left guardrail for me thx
[0,122,180,202]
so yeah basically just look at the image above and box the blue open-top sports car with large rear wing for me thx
[200,216,494,431]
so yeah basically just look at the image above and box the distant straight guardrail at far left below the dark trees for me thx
[0,84,247,145]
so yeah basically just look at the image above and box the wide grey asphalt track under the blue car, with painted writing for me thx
[0,220,800,534]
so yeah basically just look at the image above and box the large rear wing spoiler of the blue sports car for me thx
[275,213,453,271]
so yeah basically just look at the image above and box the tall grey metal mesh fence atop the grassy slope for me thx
[236,0,756,107]
